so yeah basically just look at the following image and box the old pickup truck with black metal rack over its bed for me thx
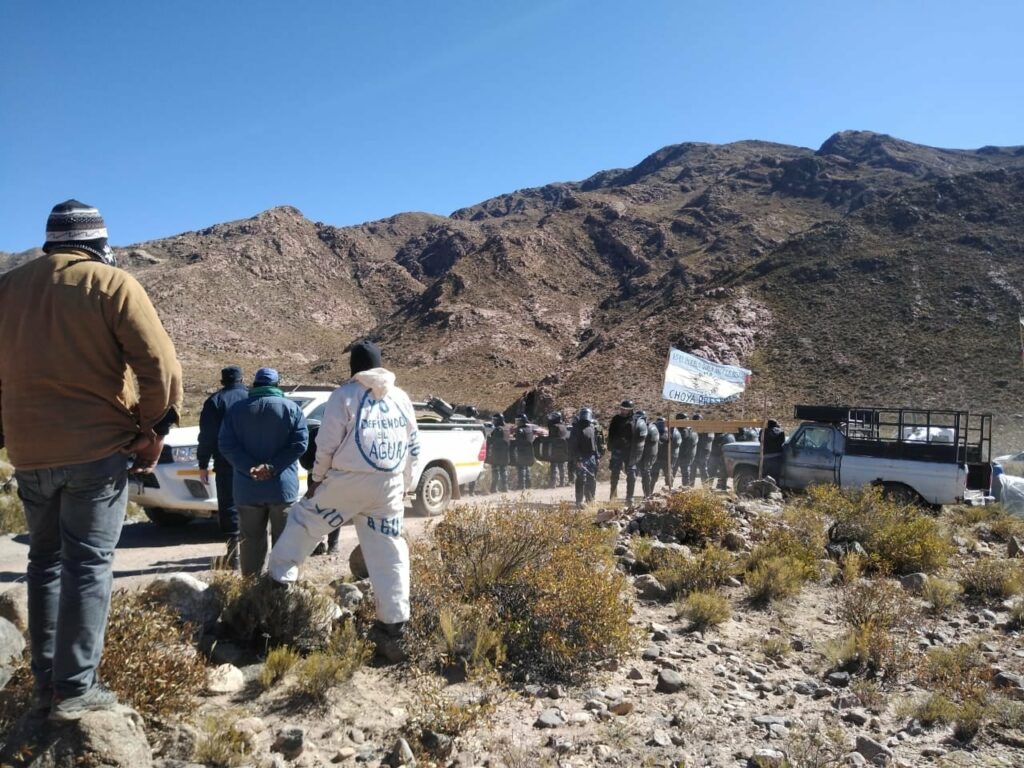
[722,406,992,506]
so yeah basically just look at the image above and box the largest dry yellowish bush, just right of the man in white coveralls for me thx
[409,505,637,680]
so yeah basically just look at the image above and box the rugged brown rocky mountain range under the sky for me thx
[6,131,1024,446]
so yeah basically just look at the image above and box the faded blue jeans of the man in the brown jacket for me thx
[15,454,128,698]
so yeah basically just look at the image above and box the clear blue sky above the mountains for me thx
[0,0,1024,251]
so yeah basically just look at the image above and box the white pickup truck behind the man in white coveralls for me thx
[129,386,486,525]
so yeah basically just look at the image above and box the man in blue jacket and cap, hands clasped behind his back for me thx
[218,368,309,575]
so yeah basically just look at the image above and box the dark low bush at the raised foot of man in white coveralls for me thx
[210,571,337,653]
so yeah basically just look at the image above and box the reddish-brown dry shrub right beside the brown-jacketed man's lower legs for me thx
[99,590,206,720]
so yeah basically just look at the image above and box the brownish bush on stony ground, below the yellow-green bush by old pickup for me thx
[825,579,914,682]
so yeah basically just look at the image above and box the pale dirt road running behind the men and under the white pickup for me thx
[0,483,608,592]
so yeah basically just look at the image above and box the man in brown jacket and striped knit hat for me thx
[0,200,182,720]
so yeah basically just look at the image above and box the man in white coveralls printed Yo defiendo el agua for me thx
[269,341,420,637]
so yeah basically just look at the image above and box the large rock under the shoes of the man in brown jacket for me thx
[0,706,153,768]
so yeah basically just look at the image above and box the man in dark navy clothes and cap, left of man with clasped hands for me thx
[196,366,249,570]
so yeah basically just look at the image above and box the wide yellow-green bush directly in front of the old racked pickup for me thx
[808,485,953,574]
